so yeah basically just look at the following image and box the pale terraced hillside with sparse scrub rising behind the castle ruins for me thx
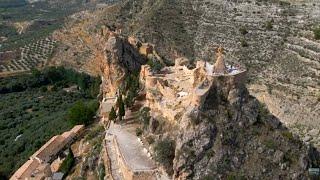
[48,0,320,147]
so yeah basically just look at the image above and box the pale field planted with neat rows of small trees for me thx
[0,38,56,76]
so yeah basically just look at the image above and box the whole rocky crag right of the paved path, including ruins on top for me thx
[140,57,320,179]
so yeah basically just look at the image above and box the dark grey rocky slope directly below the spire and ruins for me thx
[169,75,320,179]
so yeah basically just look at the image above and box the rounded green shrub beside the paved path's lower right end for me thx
[154,139,175,169]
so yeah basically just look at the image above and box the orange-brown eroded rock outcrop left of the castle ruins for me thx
[49,11,145,96]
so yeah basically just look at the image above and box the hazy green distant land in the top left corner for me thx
[0,0,115,51]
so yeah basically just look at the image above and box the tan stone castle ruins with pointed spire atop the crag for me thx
[140,48,246,122]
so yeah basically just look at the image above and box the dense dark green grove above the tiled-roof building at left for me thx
[0,67,100,177]
